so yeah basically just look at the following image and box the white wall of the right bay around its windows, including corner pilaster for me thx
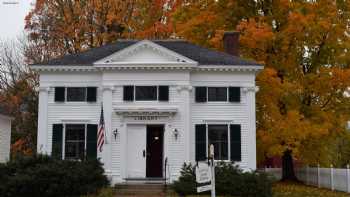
[190,73,255,170]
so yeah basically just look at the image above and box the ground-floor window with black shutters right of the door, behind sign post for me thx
[195,124,241,161]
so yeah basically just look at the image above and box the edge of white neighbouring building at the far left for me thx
[0,107,12,163]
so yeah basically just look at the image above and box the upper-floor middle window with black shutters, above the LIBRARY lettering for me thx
[123,86,169,101]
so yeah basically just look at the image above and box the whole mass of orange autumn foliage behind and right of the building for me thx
[19,0,350,174]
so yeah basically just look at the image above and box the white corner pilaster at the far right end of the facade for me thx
[242,86,258,170]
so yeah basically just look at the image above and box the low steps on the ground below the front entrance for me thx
[115,183,166,197]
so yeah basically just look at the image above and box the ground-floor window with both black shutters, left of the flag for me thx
[51,124,97,160]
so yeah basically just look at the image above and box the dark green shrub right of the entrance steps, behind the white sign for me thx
[173,163,272,197]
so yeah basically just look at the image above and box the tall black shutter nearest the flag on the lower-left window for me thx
[86,124,97,159]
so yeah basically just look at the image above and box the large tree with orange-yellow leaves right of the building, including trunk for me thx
[173,0,350,180]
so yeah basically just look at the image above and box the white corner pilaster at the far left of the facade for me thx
[37,87,50,154]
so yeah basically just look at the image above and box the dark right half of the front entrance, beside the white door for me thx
[146,125,164,178]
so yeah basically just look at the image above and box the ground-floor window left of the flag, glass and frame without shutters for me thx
[65,124,85,159]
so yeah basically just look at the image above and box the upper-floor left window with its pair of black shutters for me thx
[55,87,97,102]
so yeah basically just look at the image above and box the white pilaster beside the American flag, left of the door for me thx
[102,85,114,175]
